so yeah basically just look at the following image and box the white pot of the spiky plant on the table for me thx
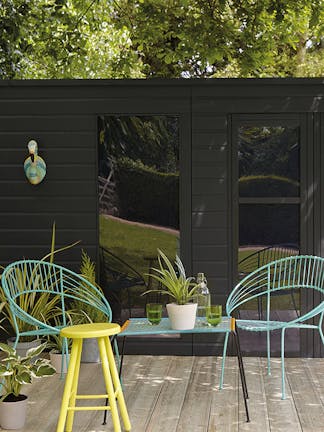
[166,303,197,330]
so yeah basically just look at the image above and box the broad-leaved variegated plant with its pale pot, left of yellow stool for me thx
[0,343,55,429]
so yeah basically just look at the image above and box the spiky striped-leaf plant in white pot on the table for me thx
[143,249,198,330]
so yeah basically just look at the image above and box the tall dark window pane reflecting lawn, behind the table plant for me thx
[98,115,179,314]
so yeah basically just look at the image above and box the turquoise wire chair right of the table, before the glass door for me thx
[220,255,324,399]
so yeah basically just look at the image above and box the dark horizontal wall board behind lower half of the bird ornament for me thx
[0,161,97,181]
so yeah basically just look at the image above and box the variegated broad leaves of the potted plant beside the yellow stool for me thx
[0,343,55,402]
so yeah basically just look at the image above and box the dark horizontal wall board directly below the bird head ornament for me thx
[0,181,97,198]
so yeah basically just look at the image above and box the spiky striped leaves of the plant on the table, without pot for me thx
[143,249,198,305]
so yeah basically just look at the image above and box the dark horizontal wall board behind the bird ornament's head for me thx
[0,147,97,167]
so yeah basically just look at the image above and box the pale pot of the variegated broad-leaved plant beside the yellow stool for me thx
[0,395,27,430]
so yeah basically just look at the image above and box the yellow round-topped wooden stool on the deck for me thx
[56,323,131,432]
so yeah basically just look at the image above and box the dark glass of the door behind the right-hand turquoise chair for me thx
[237,124,300,309]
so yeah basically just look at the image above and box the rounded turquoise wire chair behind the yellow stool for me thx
[1,260,119,374]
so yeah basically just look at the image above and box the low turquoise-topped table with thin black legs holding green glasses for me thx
[118,317,250,421]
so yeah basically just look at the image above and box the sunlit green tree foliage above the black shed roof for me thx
[0,0,324,79]
